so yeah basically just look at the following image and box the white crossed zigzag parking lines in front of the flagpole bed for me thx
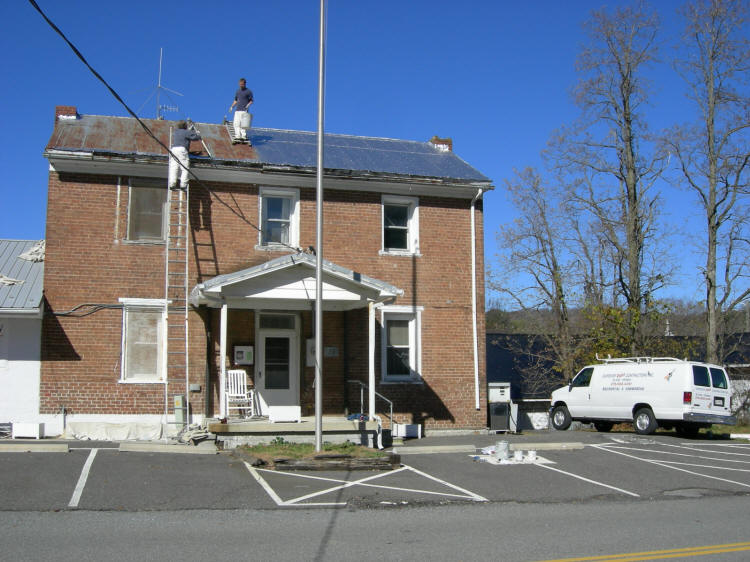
[245,463,488,507]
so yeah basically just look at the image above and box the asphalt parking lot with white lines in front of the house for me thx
[0,431,750,511]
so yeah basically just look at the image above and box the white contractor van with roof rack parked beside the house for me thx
[550,357,737,435]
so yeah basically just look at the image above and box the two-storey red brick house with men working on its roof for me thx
[40,106,492,433]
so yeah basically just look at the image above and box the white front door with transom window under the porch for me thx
[255,314,300,421]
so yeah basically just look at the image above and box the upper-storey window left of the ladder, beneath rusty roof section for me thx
[128,180,167,242]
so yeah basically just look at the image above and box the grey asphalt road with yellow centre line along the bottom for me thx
[0,496,750,562]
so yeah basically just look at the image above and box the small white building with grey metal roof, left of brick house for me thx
[0,236,44,435]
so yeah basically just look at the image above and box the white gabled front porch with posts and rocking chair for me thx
[190,254,403,430]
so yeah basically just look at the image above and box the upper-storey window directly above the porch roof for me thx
[259,188,299,248]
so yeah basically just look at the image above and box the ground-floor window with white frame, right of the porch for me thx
[381,307,421,382]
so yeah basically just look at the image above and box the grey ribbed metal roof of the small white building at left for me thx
[0,240,44,313]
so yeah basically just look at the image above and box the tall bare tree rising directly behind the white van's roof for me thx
[549,4,666,354]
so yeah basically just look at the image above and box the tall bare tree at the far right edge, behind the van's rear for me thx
[666,0,750,362]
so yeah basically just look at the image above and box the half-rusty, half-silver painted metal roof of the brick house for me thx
[46,111,490,184]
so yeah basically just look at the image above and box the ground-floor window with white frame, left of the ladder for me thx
[120,299,164,382]
